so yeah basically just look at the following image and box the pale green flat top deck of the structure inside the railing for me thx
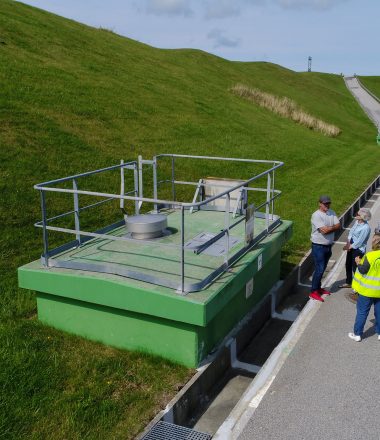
[35,210,289,292]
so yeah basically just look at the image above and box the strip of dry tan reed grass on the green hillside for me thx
[231,84,341,137]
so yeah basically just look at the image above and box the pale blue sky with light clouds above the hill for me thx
[23,0,380,76]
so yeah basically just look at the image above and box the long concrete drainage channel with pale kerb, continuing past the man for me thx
[137,176,380,440]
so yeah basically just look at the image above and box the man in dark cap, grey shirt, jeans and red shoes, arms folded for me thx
[309,196,340,302]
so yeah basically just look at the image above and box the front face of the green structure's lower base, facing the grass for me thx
[37,293,198,367]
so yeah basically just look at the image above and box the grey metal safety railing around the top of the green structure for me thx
[34,154,283,294]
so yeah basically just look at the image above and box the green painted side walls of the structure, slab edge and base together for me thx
[19,221,291,367]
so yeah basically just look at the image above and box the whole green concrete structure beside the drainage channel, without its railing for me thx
[18,210,292,367]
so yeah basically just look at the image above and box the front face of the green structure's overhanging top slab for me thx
[18,262,204,325]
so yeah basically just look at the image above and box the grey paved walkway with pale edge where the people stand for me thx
[213,189,380,440]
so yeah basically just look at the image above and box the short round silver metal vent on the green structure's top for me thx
[125,214,168,240]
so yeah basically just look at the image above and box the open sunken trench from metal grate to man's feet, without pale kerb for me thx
[138,283,300,440]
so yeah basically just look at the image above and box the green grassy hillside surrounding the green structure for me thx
[0,0,379,439]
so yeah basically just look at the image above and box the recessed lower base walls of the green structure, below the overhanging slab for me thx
[37,249,280,367]
